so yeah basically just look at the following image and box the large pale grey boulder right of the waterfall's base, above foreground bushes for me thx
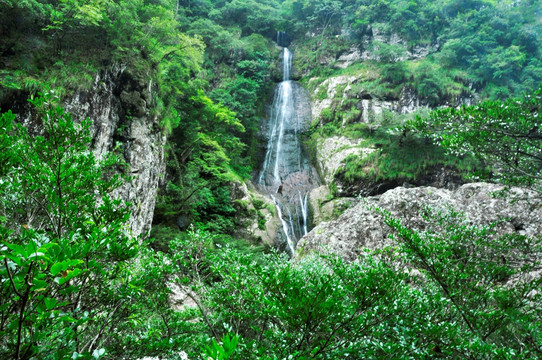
[297,183,542,260]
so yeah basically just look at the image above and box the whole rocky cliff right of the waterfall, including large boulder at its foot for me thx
[296,24,542,260]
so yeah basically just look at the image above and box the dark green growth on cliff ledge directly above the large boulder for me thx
[307,109,489,193]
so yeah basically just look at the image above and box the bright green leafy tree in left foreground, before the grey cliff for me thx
[0,93,140,360]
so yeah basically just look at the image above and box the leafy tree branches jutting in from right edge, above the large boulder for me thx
[406,87,542,191]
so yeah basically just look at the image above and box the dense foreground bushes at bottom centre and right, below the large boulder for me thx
[153,202,542,359]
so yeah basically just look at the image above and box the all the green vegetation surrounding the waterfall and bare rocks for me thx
[0,0,542,360]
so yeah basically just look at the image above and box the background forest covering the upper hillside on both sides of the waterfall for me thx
[0,0,542,233]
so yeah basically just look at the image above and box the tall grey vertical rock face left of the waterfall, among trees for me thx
[15,66,166,236]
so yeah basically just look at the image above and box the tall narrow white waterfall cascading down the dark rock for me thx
[257,33,318,256]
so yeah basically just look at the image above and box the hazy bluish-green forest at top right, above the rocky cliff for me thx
[283,0,542,100]
